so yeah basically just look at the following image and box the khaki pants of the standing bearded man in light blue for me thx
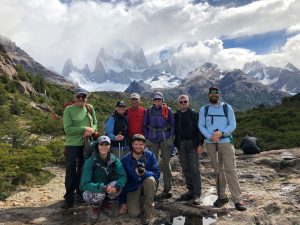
[206,143,241,203]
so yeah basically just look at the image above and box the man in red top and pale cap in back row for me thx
[127,93,145,139]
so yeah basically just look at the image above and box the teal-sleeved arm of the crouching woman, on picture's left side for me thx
[80,157,105,193]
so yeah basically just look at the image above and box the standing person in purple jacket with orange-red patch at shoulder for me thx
[143,92,175,198]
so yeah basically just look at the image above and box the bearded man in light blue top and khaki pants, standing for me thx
[198,87,246,211]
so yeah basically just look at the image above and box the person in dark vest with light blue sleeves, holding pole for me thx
[105,101,130,159]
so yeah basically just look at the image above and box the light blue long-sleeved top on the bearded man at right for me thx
[198,102,236,143]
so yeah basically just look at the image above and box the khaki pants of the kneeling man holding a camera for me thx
[127,177,156,217]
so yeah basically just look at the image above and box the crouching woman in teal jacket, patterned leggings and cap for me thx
[80,136,127,222]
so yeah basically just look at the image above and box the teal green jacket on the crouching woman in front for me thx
[80,146,127,193]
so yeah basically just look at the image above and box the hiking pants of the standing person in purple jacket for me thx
[147,139,173,192]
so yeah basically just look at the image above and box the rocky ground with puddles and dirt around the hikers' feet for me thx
[0,148,300,225]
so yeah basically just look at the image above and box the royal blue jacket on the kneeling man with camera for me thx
[120,150,160,204]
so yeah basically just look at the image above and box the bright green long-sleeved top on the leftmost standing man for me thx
[63,104,97,146]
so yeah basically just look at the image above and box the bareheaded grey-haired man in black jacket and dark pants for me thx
[174,95,204,205]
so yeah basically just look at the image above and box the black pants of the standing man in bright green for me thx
[64,146,84,204]
